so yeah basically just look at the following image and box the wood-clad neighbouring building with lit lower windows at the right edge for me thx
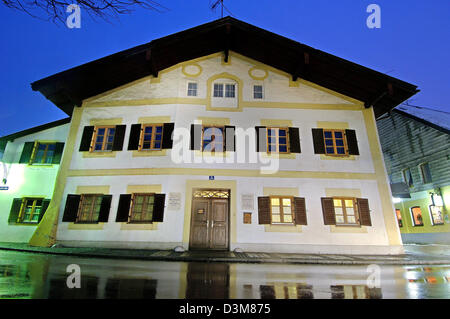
[377,105,450,244]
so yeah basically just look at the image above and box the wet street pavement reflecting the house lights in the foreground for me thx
[0,251,450,299]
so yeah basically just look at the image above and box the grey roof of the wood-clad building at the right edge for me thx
[394,104,450,134]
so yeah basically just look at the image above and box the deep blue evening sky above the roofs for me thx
[0,0,450,136]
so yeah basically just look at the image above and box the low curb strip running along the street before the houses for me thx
[0,247,450,265]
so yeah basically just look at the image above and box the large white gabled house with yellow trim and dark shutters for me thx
[24,17,417,254]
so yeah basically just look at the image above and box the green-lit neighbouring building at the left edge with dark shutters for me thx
[0,118,70,242]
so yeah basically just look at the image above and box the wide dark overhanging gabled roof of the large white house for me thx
[31,17,418,117]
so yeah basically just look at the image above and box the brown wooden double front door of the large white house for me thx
[189,190,229,250]
